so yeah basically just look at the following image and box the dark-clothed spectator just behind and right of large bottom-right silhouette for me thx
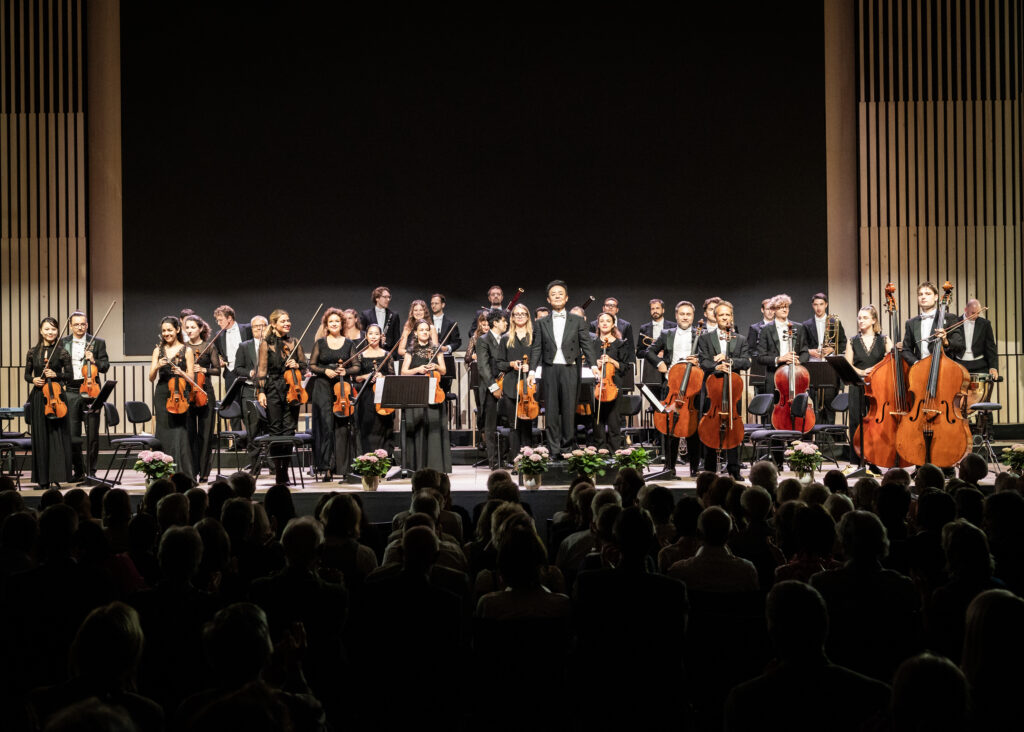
[811,511,921,680]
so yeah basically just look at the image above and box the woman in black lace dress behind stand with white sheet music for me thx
[401,320,450,473]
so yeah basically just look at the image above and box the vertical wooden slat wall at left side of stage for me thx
[0,0,87,432]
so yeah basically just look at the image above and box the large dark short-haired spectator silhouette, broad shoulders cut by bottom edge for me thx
[725,580,890,732]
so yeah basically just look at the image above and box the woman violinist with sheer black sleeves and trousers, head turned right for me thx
[256,309,306,484]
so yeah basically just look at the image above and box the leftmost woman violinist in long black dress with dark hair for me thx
[25,317,74,483]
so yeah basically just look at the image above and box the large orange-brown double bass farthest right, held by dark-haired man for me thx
[896,282,971,468]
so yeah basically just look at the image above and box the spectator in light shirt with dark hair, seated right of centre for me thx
[669,506,759,592]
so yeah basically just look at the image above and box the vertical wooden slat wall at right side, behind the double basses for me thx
[856,0,1024,423]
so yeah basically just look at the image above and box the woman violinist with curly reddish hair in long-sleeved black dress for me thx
[309,307,359,480]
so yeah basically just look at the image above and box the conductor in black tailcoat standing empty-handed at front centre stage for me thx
[529,279,599,457]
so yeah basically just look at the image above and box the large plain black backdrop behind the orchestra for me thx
[122,2,826,354]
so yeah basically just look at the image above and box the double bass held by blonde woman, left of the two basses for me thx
[853,283,910,468]
